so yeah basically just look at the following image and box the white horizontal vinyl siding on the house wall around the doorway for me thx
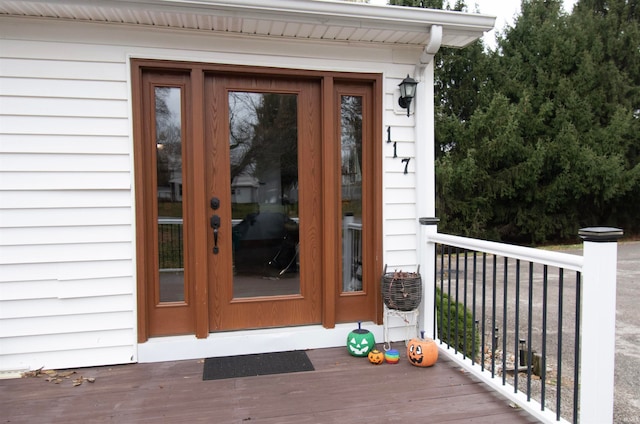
[0,14,428,370]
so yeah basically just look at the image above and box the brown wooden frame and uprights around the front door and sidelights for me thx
[131,59,383,343]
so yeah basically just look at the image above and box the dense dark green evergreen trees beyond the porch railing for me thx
[396,0,640,244]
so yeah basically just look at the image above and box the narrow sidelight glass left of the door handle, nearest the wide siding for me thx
[155,87,185,302]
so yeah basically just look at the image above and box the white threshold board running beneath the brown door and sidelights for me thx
[138,322,383,363]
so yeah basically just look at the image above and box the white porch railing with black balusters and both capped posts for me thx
[420,219,622,424]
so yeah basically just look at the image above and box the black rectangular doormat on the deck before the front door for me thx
[202,350,314,380]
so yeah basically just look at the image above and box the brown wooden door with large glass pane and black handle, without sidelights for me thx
[204,74,322,331]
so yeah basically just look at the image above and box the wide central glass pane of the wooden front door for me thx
[228,91,300,298]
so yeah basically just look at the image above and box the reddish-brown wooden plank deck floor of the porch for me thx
[0,344,536,424]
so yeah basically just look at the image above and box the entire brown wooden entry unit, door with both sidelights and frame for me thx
[132,60,382,342]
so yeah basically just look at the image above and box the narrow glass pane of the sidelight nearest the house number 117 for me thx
[340,96,362,292]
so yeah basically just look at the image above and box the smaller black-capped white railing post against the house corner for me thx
[418,218,440,339]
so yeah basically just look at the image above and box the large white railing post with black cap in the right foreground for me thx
[578,227,623,424]
